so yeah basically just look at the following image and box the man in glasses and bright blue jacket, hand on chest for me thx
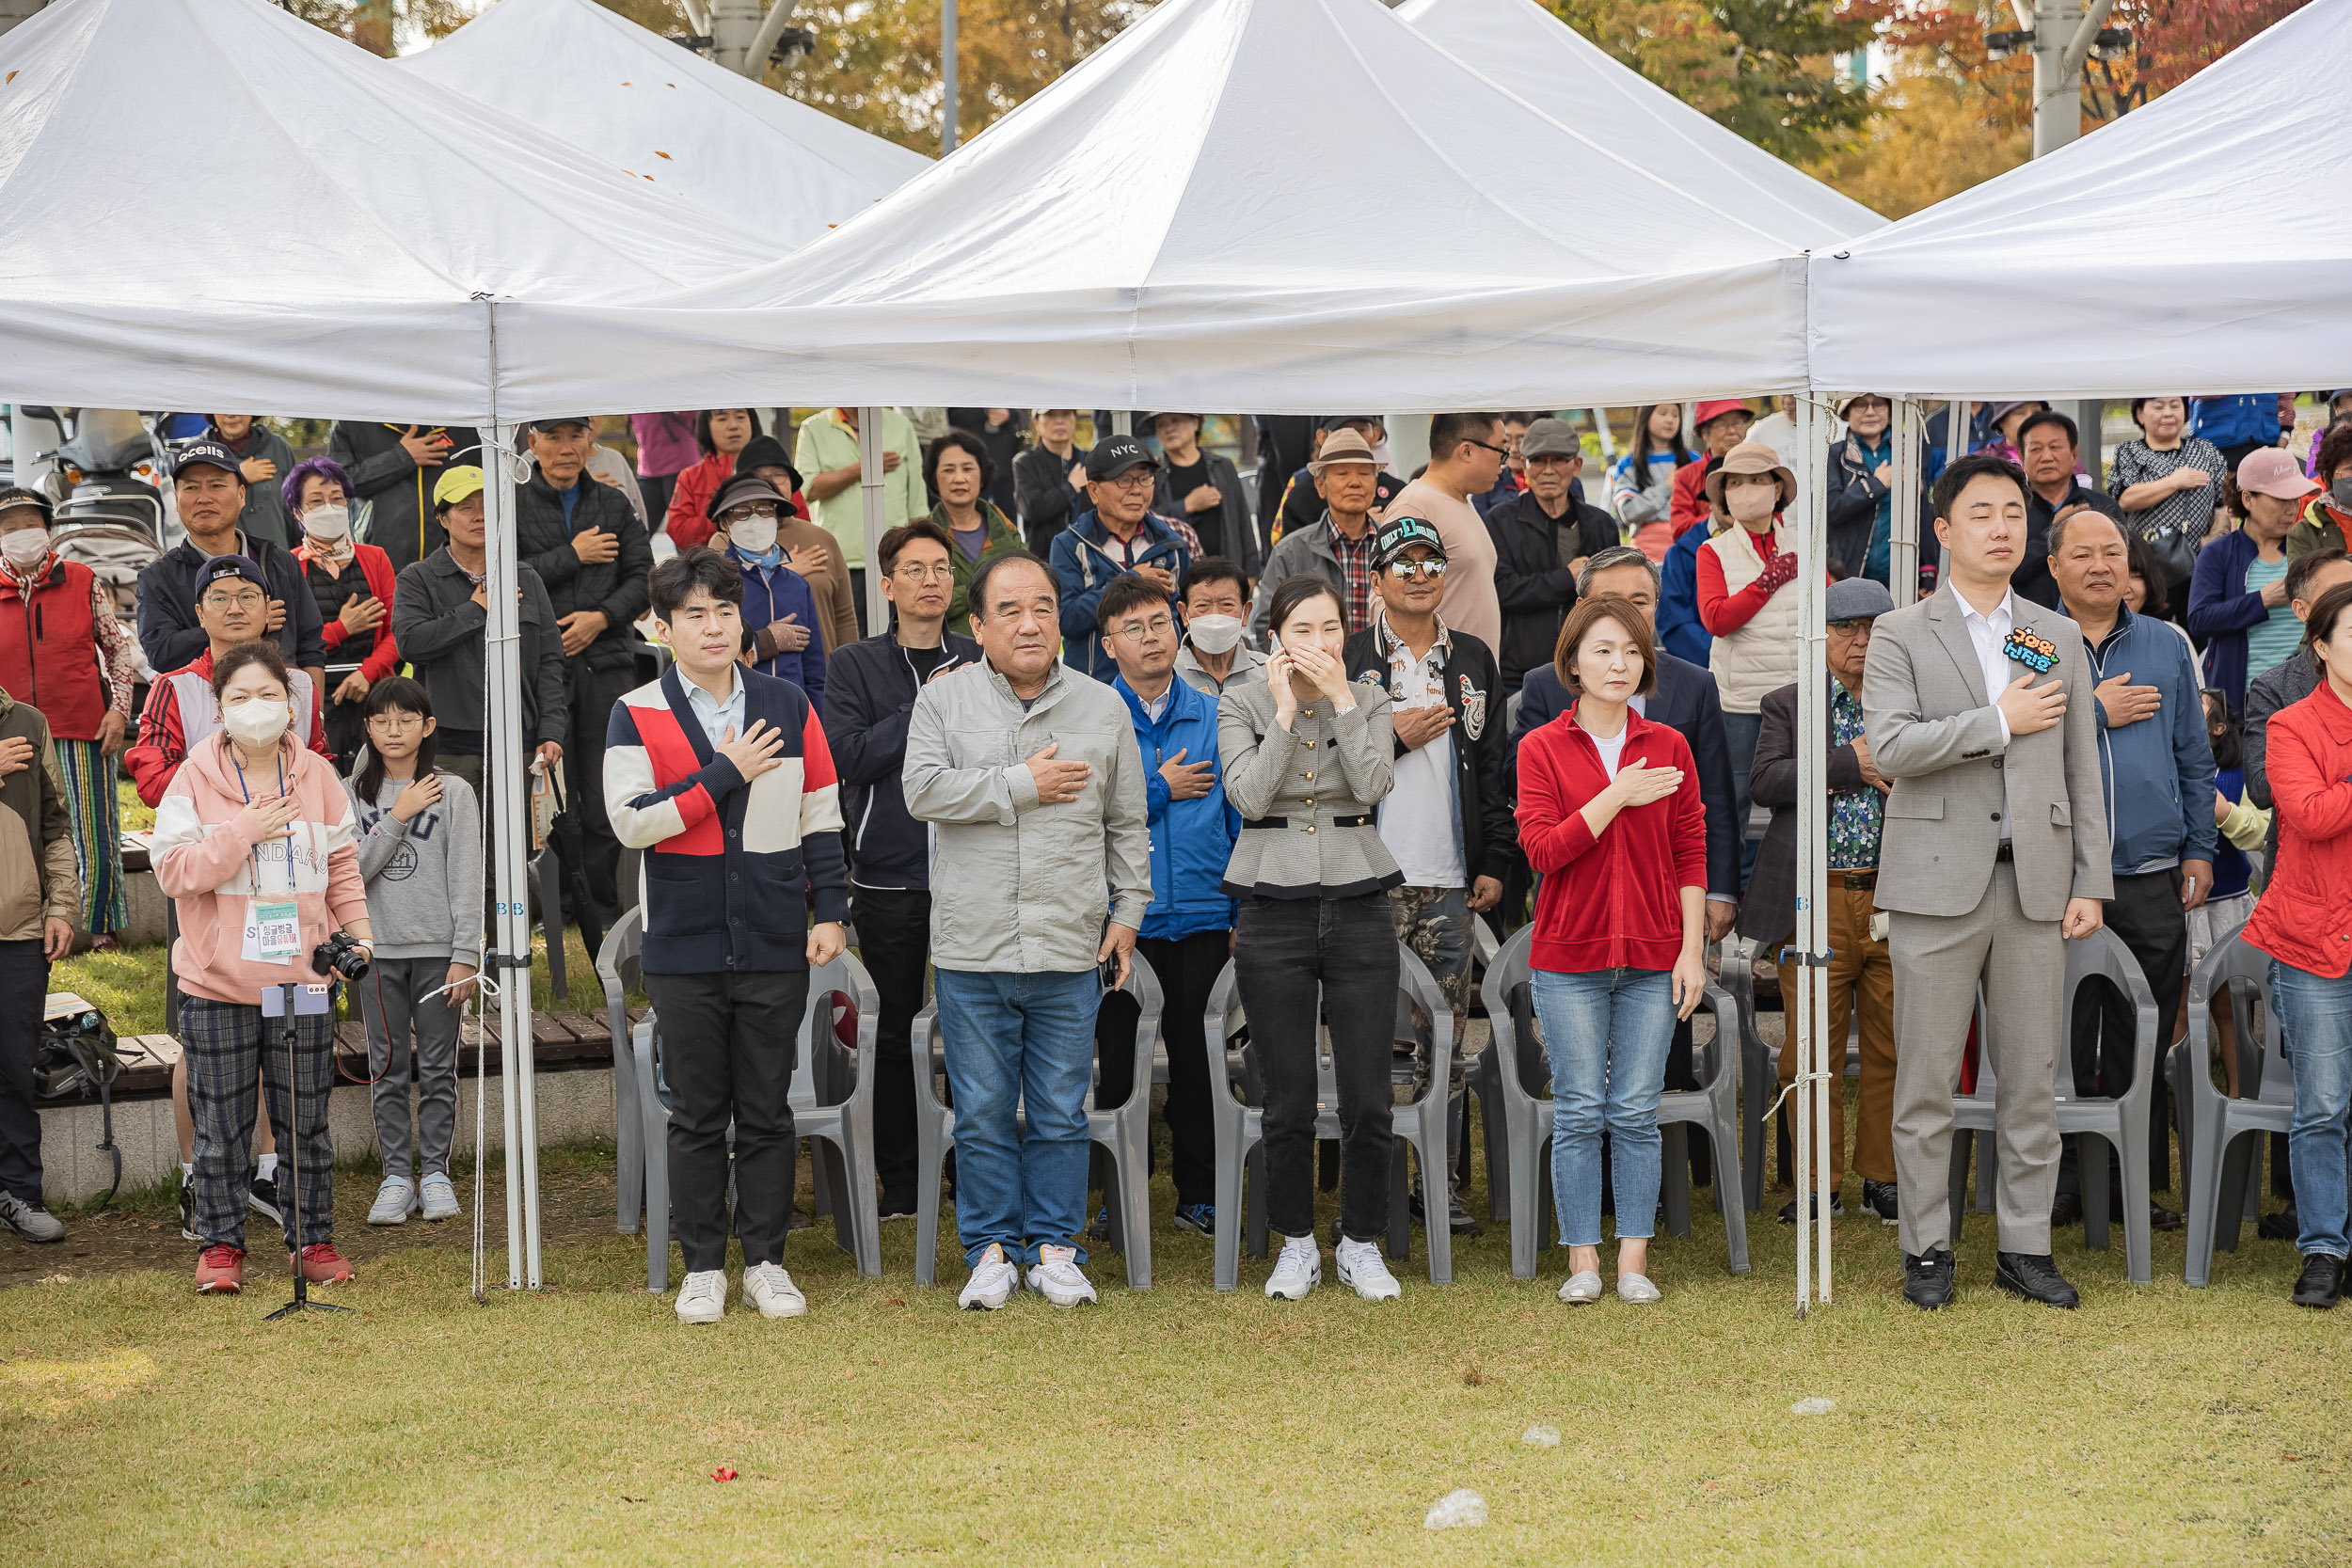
[1094,571,1242,1237]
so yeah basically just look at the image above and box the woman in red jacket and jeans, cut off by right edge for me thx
[2247,583,2352,1307]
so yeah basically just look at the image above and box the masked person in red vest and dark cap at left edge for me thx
[0,486,141,947]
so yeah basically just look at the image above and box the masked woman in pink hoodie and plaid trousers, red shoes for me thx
[153,641,370,1295]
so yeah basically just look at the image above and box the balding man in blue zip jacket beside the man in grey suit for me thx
[2049,508,2216,1229]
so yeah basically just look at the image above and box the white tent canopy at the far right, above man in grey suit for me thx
[1811,0,2352,397]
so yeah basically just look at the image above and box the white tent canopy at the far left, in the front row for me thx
[0,0,774,423]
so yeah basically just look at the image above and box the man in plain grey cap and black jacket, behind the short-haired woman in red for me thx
[1486,419,1618,691]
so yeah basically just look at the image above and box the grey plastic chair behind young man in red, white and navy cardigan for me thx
[630,952,882,1293]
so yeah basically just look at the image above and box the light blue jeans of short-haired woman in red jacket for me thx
[1534,969,1675,1246]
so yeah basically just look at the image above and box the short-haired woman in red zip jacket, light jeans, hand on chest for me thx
[1519,594,1708,1305]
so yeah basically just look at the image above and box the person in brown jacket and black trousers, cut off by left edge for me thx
[0,691,83,1242]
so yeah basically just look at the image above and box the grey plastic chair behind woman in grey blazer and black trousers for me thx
[1202,942,1454,1291]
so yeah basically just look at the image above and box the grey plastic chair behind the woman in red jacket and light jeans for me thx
[1486,927,1748,1279]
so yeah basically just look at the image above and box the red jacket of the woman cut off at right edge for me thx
[2247,682,2352,980]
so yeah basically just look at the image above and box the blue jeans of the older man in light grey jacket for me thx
[931,969,1101,1265]
